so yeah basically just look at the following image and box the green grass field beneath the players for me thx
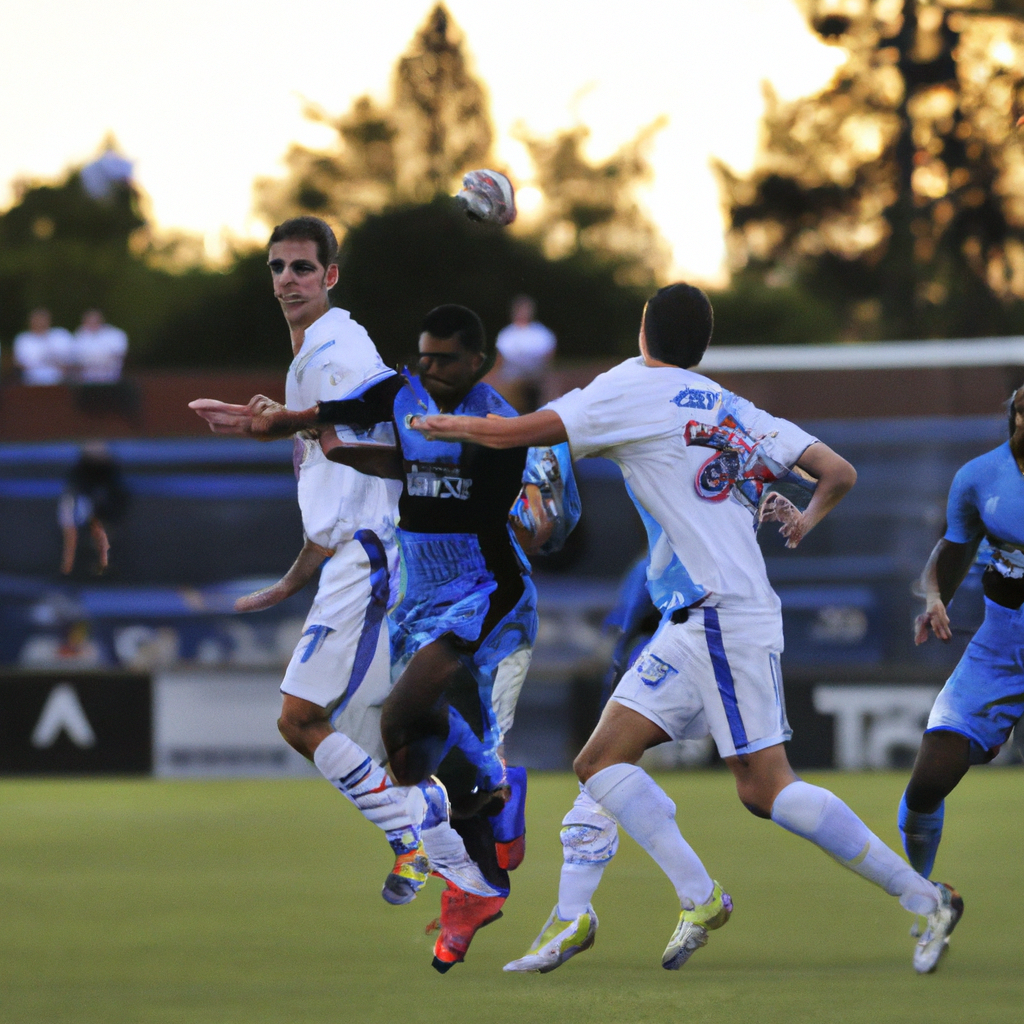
[0,769,1024,1024]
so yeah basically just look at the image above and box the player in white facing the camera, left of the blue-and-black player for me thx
[189,217,444,903]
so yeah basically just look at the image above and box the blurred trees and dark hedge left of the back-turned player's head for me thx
[0,5,667,367]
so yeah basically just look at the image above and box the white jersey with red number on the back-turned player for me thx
[547,356,816,615]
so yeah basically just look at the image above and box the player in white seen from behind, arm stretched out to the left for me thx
[417,284,955,972]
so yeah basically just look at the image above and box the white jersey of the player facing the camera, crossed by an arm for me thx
[285,308,401,550]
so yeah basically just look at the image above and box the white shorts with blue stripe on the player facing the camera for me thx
[281,531,395,763]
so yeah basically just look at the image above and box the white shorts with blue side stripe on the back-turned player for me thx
[611,608,793,758]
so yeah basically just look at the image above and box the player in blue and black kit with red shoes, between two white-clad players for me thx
[317,305,578,971]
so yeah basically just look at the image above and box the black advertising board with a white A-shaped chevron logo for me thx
[0,672,153,774]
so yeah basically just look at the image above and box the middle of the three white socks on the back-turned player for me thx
[585,764,715,909]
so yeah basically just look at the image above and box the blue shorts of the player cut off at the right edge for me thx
[926,597,1024,752]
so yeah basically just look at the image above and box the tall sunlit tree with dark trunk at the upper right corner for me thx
[718,0,1024,338]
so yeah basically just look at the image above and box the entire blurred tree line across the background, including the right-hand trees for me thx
[0,0,1024,367]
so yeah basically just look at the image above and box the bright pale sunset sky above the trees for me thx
[0,0,842,280]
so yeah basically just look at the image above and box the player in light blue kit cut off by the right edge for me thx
[899,387,1024,970]
